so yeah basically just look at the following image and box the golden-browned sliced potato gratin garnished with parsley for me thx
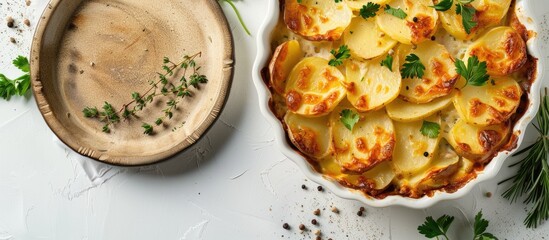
[263,0,537,198]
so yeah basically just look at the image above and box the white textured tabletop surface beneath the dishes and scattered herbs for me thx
[0,0,549,240]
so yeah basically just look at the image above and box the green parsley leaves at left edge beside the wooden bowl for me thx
[0,56,30,100]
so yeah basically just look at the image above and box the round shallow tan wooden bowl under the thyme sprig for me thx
[31,0,234,166]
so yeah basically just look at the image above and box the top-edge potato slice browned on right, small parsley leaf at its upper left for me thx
[376,0,438,44]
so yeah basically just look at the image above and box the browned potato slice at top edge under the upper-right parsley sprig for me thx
[434,0,511,40]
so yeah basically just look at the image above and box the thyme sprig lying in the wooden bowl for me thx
[82,52,208,135]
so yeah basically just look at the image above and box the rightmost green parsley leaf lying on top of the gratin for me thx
[455,56,490,87]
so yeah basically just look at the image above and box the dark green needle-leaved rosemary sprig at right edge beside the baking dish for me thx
[500,88,549,228]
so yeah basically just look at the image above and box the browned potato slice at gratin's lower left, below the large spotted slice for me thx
[284,112,331,159]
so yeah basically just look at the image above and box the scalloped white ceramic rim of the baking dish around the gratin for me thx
[252,0,549,209]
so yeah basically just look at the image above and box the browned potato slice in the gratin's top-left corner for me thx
[284,0,353,41]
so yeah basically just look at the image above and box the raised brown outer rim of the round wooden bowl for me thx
[30,0,235,166]
